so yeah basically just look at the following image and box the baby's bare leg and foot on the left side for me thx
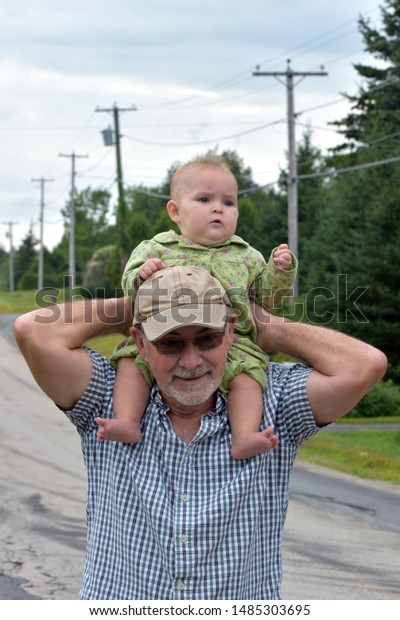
[96,357,149,443]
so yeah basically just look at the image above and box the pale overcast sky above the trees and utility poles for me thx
[0,0,381,250]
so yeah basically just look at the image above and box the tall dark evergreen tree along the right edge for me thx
[304,0,400,381]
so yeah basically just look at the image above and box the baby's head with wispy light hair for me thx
[167,155,238,246]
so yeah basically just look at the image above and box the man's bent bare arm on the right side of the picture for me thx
[254,306,387,426]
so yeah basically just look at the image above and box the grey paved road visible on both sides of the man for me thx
[0,317,400,600]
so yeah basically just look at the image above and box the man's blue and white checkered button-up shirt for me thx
[66,351,318,600]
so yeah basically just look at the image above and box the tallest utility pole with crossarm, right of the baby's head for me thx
[253,60,328,295]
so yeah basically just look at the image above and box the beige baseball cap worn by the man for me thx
[133,265,231,340]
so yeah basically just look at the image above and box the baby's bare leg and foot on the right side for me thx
[228,373,278,459]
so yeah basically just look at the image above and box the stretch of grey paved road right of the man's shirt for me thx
[283,462,400,600]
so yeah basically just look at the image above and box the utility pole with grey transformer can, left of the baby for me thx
[96,103,137,268]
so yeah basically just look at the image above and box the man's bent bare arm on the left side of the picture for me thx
[14,298,132,409]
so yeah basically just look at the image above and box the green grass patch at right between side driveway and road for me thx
[298,432,400,484]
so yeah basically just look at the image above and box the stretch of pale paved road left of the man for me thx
[0,317,86,600]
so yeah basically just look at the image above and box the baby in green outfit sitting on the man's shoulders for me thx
[97,155,297,459]
